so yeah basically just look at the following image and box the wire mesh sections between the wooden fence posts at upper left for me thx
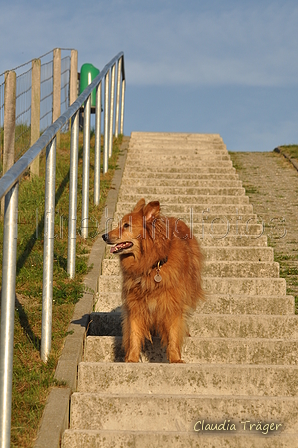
[0,48,71,172]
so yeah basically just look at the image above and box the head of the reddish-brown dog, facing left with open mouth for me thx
[102,199,160,254]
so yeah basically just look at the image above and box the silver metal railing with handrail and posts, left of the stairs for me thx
[0,52,125,448]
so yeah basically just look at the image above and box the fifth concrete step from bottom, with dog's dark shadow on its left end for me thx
[89,311,298,341]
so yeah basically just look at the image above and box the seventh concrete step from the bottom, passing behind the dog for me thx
[98,275,286,296]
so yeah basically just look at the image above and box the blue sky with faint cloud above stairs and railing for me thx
[0,0,298,151]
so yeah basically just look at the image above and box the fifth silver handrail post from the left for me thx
[94,81,102,205]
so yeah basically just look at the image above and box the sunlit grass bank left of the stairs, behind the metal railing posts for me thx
[0,129,122,448]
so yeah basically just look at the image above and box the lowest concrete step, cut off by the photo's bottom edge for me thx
[62,427,298,448]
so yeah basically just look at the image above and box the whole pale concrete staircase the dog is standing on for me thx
[62,132,298,448]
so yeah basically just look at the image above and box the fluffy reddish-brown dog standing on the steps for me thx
[102,199,203,362]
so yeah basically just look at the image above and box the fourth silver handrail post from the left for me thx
[81,94,91,239]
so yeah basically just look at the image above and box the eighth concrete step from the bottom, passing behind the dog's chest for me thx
[102,259,279,278]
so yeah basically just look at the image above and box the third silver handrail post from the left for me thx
[67,111,79,278]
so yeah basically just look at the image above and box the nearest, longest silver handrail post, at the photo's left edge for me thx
[0,183,19,448]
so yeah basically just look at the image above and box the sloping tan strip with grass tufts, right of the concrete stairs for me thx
[230,145,298,314]
